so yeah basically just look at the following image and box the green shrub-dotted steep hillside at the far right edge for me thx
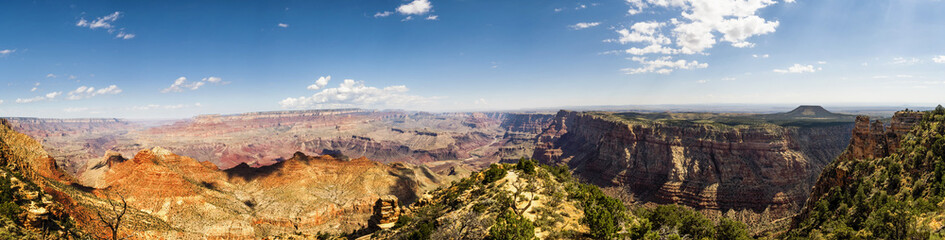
[783,108,945,239]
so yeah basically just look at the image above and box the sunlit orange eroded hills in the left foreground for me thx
[0,119,458,239]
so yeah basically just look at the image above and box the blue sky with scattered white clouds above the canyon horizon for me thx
[0,0,945,118]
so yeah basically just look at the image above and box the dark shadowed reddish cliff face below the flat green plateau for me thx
[533,111,853,218]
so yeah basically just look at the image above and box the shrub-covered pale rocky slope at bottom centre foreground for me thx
[364,159,748,239]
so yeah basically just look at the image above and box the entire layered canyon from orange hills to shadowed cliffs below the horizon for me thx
[4,106,900,238]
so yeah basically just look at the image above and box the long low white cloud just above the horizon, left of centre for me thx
[279,77,432,108]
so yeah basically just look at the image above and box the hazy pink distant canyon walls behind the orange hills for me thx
[11,109,552,175]
